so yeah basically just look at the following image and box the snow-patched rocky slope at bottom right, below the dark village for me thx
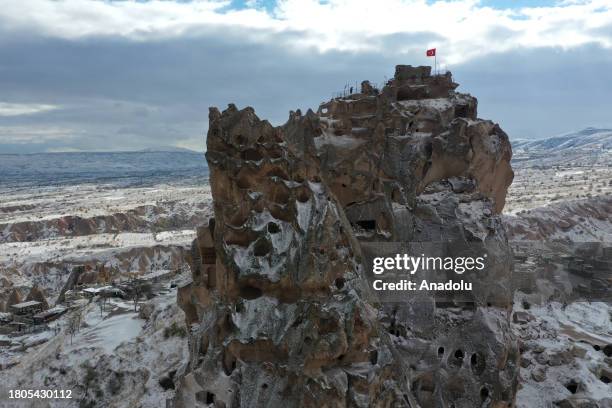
[514,293,612,408]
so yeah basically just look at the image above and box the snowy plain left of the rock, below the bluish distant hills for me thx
[0,179,212,311]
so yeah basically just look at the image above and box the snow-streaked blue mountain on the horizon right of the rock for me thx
[511,127,612,153]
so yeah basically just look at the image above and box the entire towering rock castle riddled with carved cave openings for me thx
[175,66,518,408]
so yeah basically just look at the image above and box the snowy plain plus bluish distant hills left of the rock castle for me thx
[0,152,212,311]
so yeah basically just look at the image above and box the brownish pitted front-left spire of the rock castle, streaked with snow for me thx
[178,106,416,407]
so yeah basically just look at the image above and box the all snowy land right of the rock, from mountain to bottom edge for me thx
[504,129,612,408]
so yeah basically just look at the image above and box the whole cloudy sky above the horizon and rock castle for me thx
[0,0,612,153]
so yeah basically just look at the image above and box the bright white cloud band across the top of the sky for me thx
[0,0,612,64]
